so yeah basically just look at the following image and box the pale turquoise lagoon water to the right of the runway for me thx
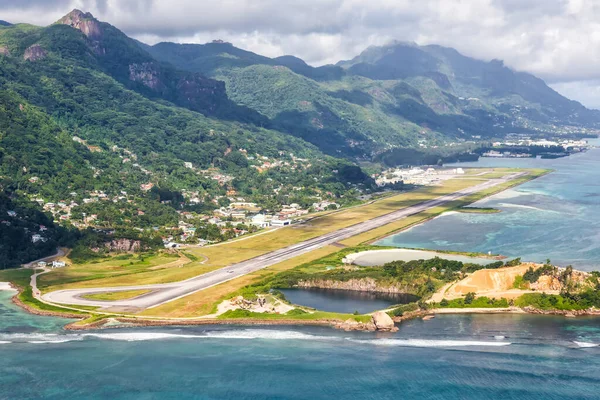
[377,149,600,270]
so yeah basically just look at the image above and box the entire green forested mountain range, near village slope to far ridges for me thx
[0,10,600,268]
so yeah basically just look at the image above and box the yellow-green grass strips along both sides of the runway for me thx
[24,169,545,317]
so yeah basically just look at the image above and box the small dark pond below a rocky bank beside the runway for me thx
[279,288,419,314]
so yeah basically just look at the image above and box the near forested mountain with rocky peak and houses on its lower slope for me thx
[0,10,372,268]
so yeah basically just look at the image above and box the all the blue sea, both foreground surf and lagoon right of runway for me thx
[0,150,600,400]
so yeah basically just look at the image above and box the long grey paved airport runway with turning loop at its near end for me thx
[42,173,526,309]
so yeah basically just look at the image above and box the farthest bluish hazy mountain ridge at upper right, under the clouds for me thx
[337,42,600,126]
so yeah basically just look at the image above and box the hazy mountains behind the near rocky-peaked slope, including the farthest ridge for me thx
[144,41,600,159]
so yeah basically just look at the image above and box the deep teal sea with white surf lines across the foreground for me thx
[0,296,600,400]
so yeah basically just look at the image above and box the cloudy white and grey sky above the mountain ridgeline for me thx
[0,0,600,108]
